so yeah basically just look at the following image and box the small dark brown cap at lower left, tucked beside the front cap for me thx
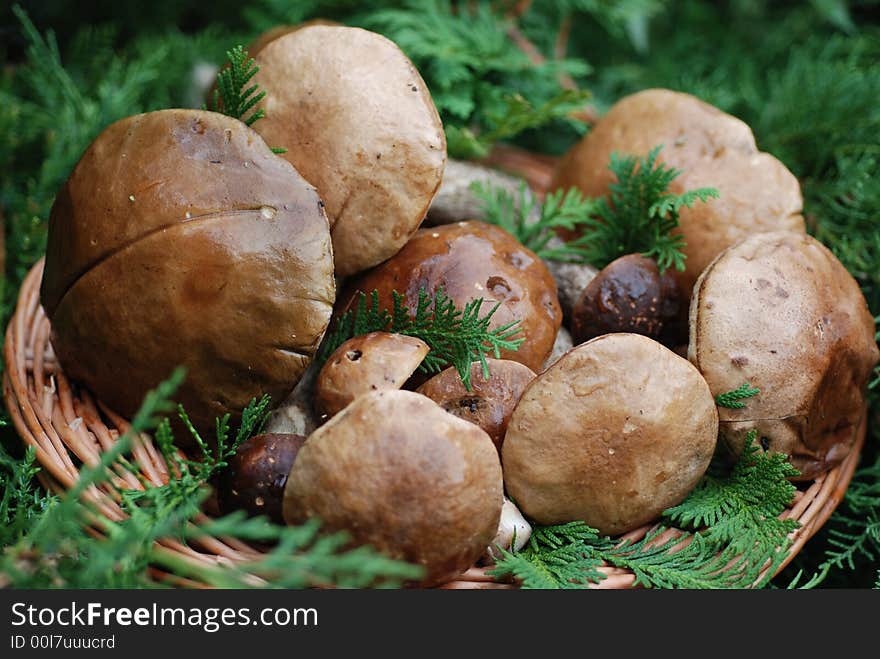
[217,433,306,524]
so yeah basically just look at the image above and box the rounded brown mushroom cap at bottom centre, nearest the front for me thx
[284,390,503,585]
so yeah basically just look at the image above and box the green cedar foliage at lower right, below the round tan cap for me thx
[492,432,798,589]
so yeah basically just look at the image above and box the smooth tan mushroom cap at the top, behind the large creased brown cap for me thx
[253,25,446,276]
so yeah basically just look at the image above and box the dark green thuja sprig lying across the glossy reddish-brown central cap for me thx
[317,288,525,390]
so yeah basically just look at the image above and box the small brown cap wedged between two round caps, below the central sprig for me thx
[416,359,535,451]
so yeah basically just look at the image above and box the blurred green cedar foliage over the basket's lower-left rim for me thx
[0,371,421,588]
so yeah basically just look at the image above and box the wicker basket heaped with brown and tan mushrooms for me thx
[4,23,878,588]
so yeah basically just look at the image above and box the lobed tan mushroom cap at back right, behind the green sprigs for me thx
[551,89,804,292]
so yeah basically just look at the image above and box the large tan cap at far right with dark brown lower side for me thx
[688,232,878,479]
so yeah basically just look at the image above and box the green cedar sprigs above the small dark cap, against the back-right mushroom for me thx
[474,146,718,272]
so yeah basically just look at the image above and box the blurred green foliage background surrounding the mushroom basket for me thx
[0,0,880,588]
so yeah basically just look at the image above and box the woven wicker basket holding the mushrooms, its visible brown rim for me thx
[3,151,866,589]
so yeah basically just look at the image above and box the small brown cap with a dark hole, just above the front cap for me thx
[315,332,430,416]
